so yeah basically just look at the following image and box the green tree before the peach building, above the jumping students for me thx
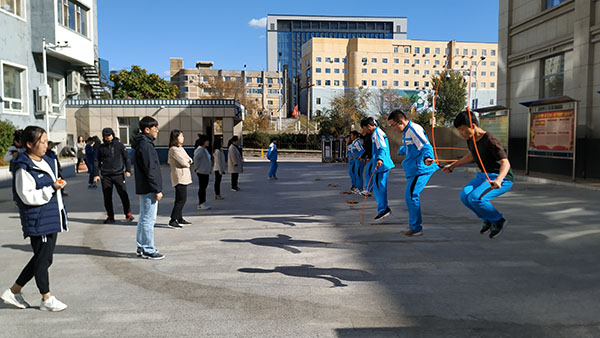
[431,72,467,121]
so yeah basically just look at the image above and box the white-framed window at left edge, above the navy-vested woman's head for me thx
[2,63,27,112]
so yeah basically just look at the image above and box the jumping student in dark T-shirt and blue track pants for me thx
[442,111,514,238]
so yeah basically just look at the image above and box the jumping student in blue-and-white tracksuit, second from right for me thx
[388,109,439,236]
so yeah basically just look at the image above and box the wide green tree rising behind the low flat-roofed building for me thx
[110,65,179,99]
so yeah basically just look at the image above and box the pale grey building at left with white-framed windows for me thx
[0,0,101,147]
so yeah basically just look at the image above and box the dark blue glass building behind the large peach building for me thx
[267,14,407,115]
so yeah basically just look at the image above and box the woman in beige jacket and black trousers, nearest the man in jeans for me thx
[168,129,193,228]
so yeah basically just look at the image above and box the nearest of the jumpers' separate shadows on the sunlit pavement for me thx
[238,264,376,288]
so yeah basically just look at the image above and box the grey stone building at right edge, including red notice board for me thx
[498,0,600,178]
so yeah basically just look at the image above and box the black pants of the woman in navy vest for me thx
[15,234,58,294]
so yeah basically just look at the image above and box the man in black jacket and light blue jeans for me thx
[132,116,165,259]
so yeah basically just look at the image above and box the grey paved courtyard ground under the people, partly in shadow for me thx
[0,161,600,338]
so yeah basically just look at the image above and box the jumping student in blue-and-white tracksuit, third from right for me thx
[361,117,395,221]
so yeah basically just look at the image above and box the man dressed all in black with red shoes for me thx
[94,128,133,224]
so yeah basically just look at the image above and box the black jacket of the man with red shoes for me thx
[94,135,131,176]
